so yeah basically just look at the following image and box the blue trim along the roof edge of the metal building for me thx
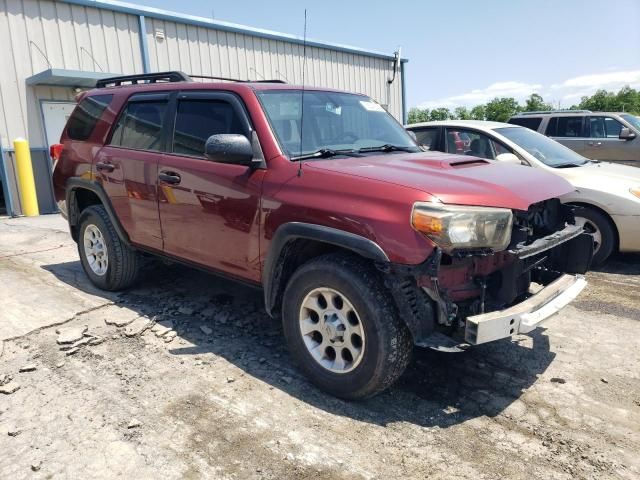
[59,0,408,64]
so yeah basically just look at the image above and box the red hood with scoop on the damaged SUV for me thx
[305,152,574,210]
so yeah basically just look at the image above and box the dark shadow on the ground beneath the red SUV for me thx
[43,262,555,428]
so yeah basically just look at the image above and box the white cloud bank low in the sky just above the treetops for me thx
[417,70,640,109]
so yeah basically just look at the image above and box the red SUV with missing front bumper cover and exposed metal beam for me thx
[52,72,593,399]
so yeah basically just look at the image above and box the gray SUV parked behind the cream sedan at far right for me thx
[509,110,640,167]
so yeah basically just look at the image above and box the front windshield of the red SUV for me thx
[256,90,420,159]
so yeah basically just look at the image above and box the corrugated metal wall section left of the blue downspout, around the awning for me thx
[0,0,142,148]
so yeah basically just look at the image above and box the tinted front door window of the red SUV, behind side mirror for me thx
[173,100,247,157]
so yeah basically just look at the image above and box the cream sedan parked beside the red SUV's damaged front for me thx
[407,120,640,265]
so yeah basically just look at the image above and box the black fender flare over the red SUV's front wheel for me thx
[262,222,389,316]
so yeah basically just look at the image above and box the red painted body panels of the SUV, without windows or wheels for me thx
[54,82,571,284]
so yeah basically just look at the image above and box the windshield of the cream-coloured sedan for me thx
[495,127,588,168]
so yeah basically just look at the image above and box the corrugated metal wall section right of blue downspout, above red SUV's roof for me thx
[146,18,402,120]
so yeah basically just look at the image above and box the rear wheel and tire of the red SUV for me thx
[78,205,140,291]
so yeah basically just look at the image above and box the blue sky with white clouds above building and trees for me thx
[136,0,640,109]
